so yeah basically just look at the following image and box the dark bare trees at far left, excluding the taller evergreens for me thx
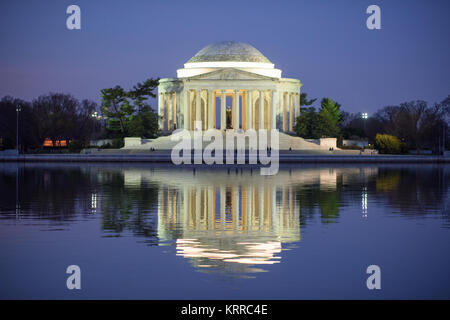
[0,93,100,151]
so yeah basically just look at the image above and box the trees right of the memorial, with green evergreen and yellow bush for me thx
[295,93,450,153]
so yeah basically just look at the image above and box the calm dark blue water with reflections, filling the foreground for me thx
[0,163,450,299]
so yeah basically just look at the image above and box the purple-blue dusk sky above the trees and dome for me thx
[0,0,450,113]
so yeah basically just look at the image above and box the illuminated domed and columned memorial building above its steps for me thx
[158,41,302,134]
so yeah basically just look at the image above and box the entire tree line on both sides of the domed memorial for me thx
[0,78,450,153]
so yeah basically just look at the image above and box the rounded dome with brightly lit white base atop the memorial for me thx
[177,41,281,78]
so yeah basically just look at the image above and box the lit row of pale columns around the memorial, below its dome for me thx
[158,88,300,132]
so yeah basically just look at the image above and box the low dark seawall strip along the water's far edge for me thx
[0,151,450,162]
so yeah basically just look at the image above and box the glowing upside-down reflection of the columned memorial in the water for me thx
[158,172,300,273]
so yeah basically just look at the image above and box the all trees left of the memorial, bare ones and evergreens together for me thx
[0,79,159,152]
